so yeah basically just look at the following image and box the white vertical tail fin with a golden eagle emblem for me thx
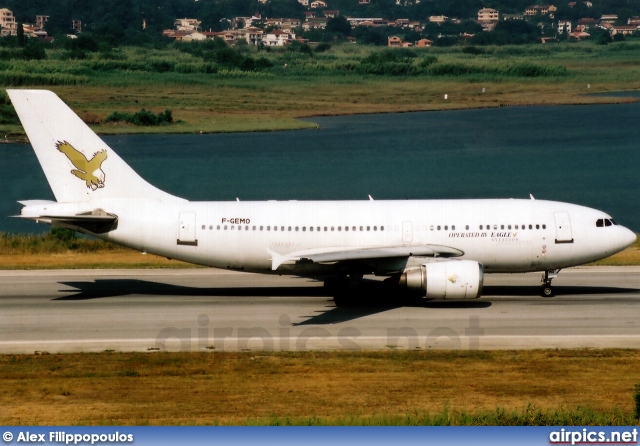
[7,90,176,203]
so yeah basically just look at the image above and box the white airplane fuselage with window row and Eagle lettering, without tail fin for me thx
[36,199,635,275]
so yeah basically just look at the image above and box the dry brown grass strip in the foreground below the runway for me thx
[0,350,640,425]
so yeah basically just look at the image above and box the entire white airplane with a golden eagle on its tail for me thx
[7,90,636,299]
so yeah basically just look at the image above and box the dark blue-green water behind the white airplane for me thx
[0,104,640,232]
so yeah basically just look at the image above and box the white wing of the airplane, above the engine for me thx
[268,245,464,271]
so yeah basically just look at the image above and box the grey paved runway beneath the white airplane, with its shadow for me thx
[0,267,640,353]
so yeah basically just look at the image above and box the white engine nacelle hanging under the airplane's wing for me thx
[399,260,484,299]
